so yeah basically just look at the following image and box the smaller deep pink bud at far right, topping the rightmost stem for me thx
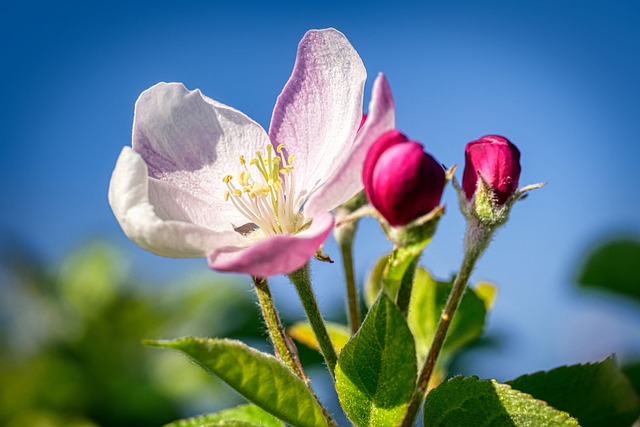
[462,135,520,206]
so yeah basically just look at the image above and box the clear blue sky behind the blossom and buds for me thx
[0,0,640,380]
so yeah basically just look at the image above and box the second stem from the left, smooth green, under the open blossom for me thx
[289,263,338,377]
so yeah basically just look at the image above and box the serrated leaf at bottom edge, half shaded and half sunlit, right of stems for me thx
[424,377,579,427]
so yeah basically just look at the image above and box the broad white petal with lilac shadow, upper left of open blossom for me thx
[132,83,269,227]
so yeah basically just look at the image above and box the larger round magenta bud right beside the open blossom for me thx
[362,130,446,226]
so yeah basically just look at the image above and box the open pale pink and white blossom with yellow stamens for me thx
[109,29,395,277]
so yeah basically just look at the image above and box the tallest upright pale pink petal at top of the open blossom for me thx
[269,28,367,199]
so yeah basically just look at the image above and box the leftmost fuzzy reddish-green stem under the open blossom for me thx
[253,277,309,384]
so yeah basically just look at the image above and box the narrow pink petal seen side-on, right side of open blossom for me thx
[304,73,396,217]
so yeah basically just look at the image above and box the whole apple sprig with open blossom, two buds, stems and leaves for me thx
[102,29,592,427]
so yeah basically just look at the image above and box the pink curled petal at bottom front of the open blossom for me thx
[209,212,334,277]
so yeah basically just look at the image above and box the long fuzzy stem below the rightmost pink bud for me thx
[401,221,494,427]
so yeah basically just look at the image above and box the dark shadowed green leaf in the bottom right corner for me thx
[508,357,640,427]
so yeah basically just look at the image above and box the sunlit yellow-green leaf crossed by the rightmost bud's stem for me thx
[408,268,487,363]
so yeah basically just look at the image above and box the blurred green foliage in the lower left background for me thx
[0,242,266,427]
